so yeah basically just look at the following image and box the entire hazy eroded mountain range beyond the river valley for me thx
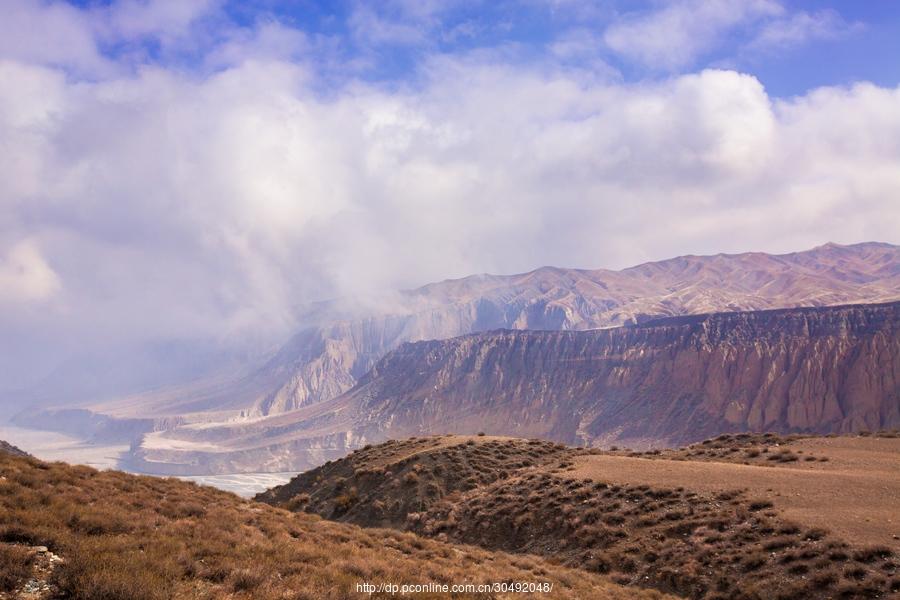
[18,243,900,473]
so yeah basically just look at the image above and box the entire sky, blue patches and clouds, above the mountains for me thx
[0,0,900,388]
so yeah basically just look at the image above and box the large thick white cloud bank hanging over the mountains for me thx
[0,3,900,392]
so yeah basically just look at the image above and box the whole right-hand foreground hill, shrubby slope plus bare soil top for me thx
[258,433,900,600]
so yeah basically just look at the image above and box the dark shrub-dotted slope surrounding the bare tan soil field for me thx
[266,436,897,600]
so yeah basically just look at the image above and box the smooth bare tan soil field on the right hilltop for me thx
[566,437,900,550]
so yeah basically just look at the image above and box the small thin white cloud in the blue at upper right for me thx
[604,0,784,70]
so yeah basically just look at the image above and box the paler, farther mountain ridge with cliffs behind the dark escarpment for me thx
[256,243,900,415]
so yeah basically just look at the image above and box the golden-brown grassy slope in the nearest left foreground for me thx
[0,451,663,600]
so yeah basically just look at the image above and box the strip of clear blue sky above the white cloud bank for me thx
[59,0,900,97]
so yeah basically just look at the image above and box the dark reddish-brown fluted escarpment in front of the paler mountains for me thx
[128,303,900,474]
